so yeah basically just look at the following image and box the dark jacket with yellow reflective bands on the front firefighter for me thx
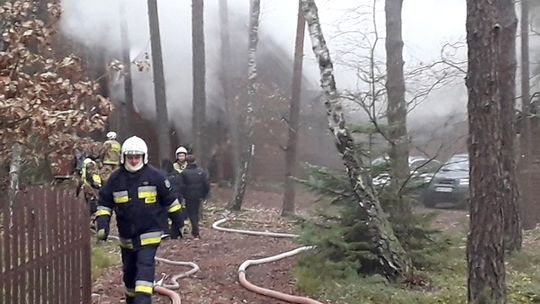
[96,165,182,248]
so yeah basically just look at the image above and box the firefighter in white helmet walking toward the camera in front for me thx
[96,136,182,304]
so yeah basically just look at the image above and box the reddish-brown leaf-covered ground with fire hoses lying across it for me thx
[93,188,467,304]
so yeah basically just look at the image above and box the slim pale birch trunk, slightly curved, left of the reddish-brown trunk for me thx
[229,0,261,210]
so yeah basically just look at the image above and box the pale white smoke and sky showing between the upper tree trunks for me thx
[61,0,502,147]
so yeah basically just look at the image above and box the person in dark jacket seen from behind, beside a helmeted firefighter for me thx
[181,155,210,240]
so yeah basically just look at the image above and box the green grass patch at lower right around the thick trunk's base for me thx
[292,230,540,304]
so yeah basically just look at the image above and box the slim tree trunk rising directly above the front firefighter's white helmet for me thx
[118,0,133,139]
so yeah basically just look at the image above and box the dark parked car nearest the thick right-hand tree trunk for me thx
[422,154,469,207]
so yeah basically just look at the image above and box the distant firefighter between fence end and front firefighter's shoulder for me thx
[77,158,102,222]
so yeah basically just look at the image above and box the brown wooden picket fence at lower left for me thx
[0,189,91,304]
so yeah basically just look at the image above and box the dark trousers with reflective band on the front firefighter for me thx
[121,245,158,304]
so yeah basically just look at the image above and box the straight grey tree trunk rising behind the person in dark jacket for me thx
[191,0,208,168]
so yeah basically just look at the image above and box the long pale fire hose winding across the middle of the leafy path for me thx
[212,218,322,304]
